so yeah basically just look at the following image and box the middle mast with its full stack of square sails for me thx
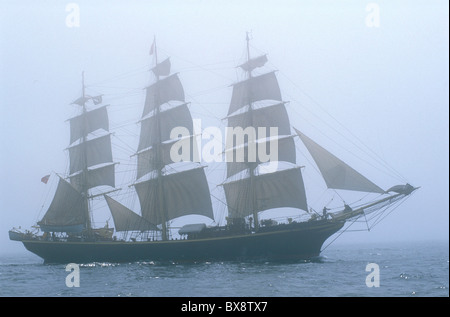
[133,37,214,240]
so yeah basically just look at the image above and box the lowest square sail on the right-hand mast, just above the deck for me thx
[223,167,308,217]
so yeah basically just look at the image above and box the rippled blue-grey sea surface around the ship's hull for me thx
[0,241,449,297]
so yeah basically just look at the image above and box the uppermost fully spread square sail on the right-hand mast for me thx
[228,72,281,115]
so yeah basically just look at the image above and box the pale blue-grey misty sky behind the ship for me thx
[0,0,449,250]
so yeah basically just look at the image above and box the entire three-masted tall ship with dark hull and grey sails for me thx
[9,36,416,263]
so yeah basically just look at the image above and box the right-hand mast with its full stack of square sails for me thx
[223,33,307,230]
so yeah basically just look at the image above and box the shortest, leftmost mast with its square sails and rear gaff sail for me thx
[38,72,117,236]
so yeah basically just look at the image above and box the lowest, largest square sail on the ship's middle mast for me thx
[134,167,214,224]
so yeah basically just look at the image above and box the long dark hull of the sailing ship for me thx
[22,220,345,263]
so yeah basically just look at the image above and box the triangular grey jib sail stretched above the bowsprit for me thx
[294,128,385,194]
